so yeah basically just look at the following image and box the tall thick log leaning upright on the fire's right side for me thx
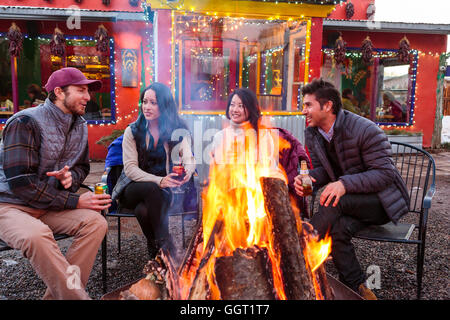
[261,177,316,300]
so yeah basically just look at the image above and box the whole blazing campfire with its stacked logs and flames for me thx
[104,127,359,300]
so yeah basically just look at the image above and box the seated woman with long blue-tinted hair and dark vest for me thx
[113,82,195,258]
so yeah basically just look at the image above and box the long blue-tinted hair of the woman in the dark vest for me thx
[136,82,187,142]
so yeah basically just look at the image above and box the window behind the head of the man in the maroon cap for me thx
[0,36,115,122]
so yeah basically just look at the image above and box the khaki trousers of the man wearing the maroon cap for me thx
[0,203,108,300]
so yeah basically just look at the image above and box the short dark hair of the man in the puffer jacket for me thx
[302,78,342,114]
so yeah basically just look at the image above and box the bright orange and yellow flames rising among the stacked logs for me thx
[180,120,329,299]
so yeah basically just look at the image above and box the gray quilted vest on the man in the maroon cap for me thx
[0,99,88,205]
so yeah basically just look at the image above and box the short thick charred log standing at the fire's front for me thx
[215,246,275,300]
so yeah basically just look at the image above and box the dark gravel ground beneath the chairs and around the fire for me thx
[0,153,450,300]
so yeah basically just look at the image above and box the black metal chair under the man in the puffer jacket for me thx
[311,141,436,299]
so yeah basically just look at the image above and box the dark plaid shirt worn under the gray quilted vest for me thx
[3,115,90,211]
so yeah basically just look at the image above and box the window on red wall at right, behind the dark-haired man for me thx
[321,48,417,125]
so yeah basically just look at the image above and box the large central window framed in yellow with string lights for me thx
[173,13,306,111]
